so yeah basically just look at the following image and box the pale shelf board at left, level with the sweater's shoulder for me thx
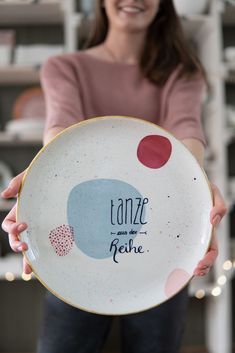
[0,64,40,85]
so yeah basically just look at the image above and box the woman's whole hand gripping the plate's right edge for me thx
[194,183,227,276]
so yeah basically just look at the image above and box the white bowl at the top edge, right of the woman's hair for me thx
[174,0,208,16]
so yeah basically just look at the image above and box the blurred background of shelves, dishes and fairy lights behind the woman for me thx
[0,0,235,353]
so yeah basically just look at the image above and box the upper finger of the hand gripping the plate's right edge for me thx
[210,183,227,226]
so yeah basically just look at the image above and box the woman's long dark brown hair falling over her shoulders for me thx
[86,0,206,85]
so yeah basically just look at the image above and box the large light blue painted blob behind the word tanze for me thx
[67,179,145,259]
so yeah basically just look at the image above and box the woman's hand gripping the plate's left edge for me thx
[1,171,32,274]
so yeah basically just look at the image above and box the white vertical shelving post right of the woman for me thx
[196,1,232,353]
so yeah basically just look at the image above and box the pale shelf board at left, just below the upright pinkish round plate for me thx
[0,132,42,146]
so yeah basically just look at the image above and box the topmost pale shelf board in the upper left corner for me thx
[0,1,63,26]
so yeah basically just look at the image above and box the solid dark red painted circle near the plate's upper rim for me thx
[137,135,172,169]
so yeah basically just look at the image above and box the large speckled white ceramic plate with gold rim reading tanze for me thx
[17,117,212,315]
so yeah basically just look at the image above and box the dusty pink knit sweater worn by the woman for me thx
[41,51,205,144]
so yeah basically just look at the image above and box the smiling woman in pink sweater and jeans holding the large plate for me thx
[2,0,226,353]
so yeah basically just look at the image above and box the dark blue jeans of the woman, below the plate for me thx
[37,288,188,353]
